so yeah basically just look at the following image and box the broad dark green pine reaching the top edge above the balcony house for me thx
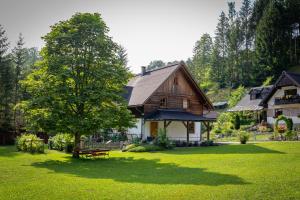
[254,1,291,84]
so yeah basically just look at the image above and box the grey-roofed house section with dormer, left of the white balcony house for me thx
[227,85,273,122]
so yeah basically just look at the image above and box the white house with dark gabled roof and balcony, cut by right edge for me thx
[259,71,300,127]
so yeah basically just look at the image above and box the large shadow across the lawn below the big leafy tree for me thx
[32,157,248,186]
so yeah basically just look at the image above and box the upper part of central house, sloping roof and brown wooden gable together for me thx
[125,62,213,114]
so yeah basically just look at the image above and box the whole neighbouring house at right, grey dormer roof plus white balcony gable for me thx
[228,71,300,127]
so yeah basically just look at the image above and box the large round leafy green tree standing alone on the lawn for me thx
[23,13,133,157]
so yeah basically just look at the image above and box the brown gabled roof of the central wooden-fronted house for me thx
[125,62,213,109]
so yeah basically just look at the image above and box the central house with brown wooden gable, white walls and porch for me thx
[125,62,216,143]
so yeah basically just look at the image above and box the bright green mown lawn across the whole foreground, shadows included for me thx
[0,142,300,200]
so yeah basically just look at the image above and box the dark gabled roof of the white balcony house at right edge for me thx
[259,71,300,106]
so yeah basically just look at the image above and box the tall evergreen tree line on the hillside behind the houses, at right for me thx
[187,0,300,90]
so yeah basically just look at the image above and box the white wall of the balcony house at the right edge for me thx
[267,86,300,125]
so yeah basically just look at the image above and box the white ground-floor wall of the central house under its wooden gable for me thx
[128,119,201,141]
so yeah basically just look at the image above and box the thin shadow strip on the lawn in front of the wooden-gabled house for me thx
[162,144,285,155]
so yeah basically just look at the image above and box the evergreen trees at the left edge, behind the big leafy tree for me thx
[0,25,39,133]
